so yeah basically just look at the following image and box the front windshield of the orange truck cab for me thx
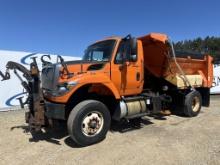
[83,40,116,62]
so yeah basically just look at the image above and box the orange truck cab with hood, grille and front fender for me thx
[42,37,144,103]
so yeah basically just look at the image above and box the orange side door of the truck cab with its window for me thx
[111,41,143,96]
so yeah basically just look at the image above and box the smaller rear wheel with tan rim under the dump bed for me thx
[184,91,202,117]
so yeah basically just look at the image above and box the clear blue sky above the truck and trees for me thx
[0,0,220,56]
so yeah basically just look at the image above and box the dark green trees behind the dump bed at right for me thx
[174,36,220,63]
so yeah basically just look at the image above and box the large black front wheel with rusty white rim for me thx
[67,100,111,146]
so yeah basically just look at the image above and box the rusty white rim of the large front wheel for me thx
[81,111,104,137]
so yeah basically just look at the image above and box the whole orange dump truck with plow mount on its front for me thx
[1,33,213,146]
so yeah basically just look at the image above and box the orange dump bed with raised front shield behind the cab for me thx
[138,33,213,88]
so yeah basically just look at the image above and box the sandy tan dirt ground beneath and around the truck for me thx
[0,96,220,165]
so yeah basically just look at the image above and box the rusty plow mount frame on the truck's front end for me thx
[0,57,47,131]
